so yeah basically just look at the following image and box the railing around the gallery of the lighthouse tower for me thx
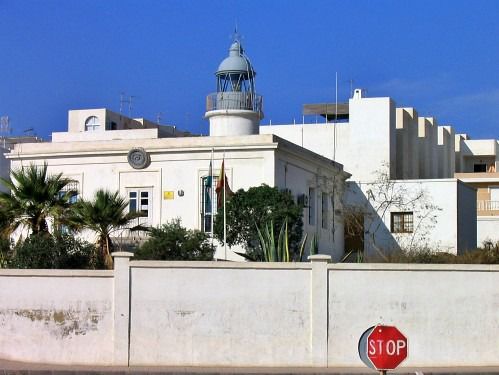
[206,91,263,113]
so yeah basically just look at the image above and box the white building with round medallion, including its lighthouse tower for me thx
[7,41,350,259]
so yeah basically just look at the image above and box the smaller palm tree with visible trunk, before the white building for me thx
[71,189,136,268]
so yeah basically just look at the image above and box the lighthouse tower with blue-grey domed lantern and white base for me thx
[205,39,263,136]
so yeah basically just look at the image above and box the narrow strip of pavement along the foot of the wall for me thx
[0,360,499,375]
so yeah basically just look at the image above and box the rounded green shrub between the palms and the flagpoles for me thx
[134,219,214,260]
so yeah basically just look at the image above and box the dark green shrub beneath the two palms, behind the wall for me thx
[7,233,103,269]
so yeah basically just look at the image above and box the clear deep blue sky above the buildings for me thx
[0,0,499,139]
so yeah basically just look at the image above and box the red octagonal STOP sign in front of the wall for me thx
[367,325,407,370]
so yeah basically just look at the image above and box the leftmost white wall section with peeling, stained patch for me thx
[0,270,113,365]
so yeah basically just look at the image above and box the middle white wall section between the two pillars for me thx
[130,262,311,367]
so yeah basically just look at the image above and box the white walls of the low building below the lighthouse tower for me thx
[7,128,349,259]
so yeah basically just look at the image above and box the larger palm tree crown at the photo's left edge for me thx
[0,163,78,234]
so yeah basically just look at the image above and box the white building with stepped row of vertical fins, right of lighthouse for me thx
[260,89,477,254]
